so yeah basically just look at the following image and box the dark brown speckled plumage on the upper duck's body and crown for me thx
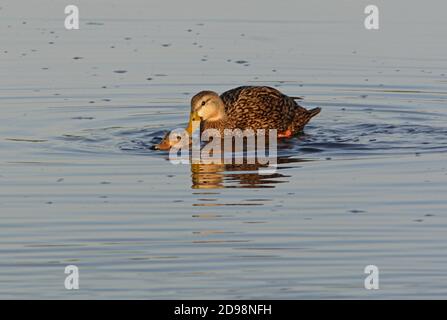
[196,86,320,134]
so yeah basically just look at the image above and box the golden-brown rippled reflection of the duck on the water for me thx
[190,156,308,189]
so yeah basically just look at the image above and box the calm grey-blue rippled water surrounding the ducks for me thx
[0,0,447,299]
